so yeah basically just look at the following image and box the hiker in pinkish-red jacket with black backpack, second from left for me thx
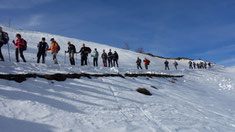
[12,34,26,62]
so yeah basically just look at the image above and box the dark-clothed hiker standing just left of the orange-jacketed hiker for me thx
[37,38,49,63]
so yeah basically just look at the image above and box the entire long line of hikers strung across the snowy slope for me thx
[0,26,211,70]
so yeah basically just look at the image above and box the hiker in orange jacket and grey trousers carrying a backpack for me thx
[48,38,60,64]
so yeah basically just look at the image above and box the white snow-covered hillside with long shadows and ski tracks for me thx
[0,27,235,132]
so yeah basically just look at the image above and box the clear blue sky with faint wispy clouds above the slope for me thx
[0,0,235,66]
